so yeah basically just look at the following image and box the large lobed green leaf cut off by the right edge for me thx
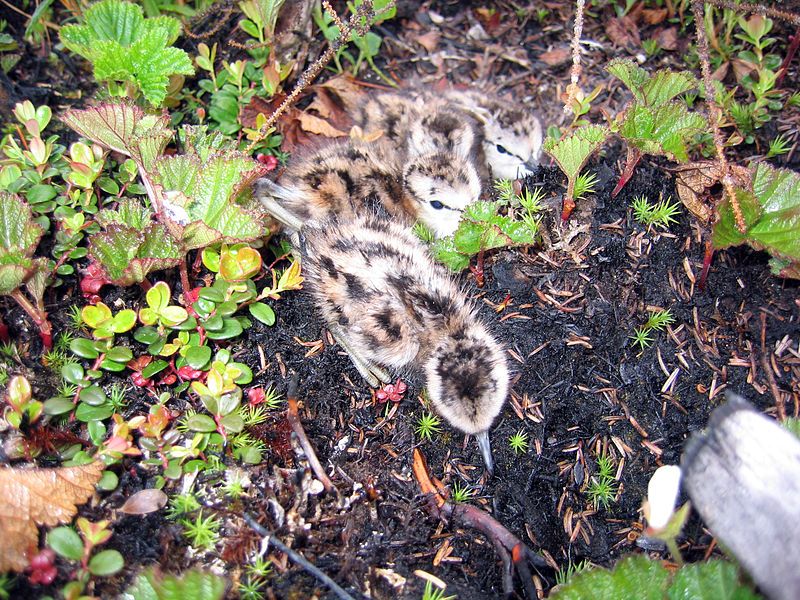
[712,163,800,276]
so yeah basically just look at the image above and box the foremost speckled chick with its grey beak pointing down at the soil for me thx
[300,216,509,471]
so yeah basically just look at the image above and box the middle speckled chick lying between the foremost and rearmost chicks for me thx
[256,130,481,237]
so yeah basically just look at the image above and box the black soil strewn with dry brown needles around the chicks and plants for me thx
[2,2,800,600]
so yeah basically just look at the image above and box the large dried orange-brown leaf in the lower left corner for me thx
[0,461,104,572]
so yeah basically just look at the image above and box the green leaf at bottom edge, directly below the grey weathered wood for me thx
[667,560,760,600]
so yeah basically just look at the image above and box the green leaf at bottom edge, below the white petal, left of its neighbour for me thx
[550,556,669,600]
